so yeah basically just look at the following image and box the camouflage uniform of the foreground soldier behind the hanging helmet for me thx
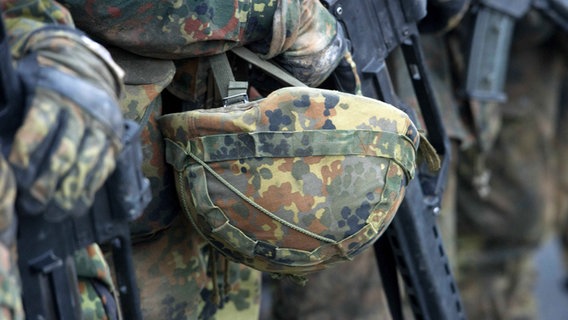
[3,0,345,319]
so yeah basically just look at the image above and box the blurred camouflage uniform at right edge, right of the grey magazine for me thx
[452,11,565,319]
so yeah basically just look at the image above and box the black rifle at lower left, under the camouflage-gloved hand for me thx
[0,13,150,319]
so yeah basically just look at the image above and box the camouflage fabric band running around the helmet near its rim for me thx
[188,130,415,179]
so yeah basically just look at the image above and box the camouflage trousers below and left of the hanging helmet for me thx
[126,216,260,320]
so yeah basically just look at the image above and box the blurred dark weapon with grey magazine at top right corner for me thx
[460,0,568,156]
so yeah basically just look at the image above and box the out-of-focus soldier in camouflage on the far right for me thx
[394,1,568,319]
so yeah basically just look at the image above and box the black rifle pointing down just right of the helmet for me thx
[323,0,465,320]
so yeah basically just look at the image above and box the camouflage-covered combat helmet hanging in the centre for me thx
[159,88,419,276]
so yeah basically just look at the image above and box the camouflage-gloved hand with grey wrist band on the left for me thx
[8,26,123,220]
